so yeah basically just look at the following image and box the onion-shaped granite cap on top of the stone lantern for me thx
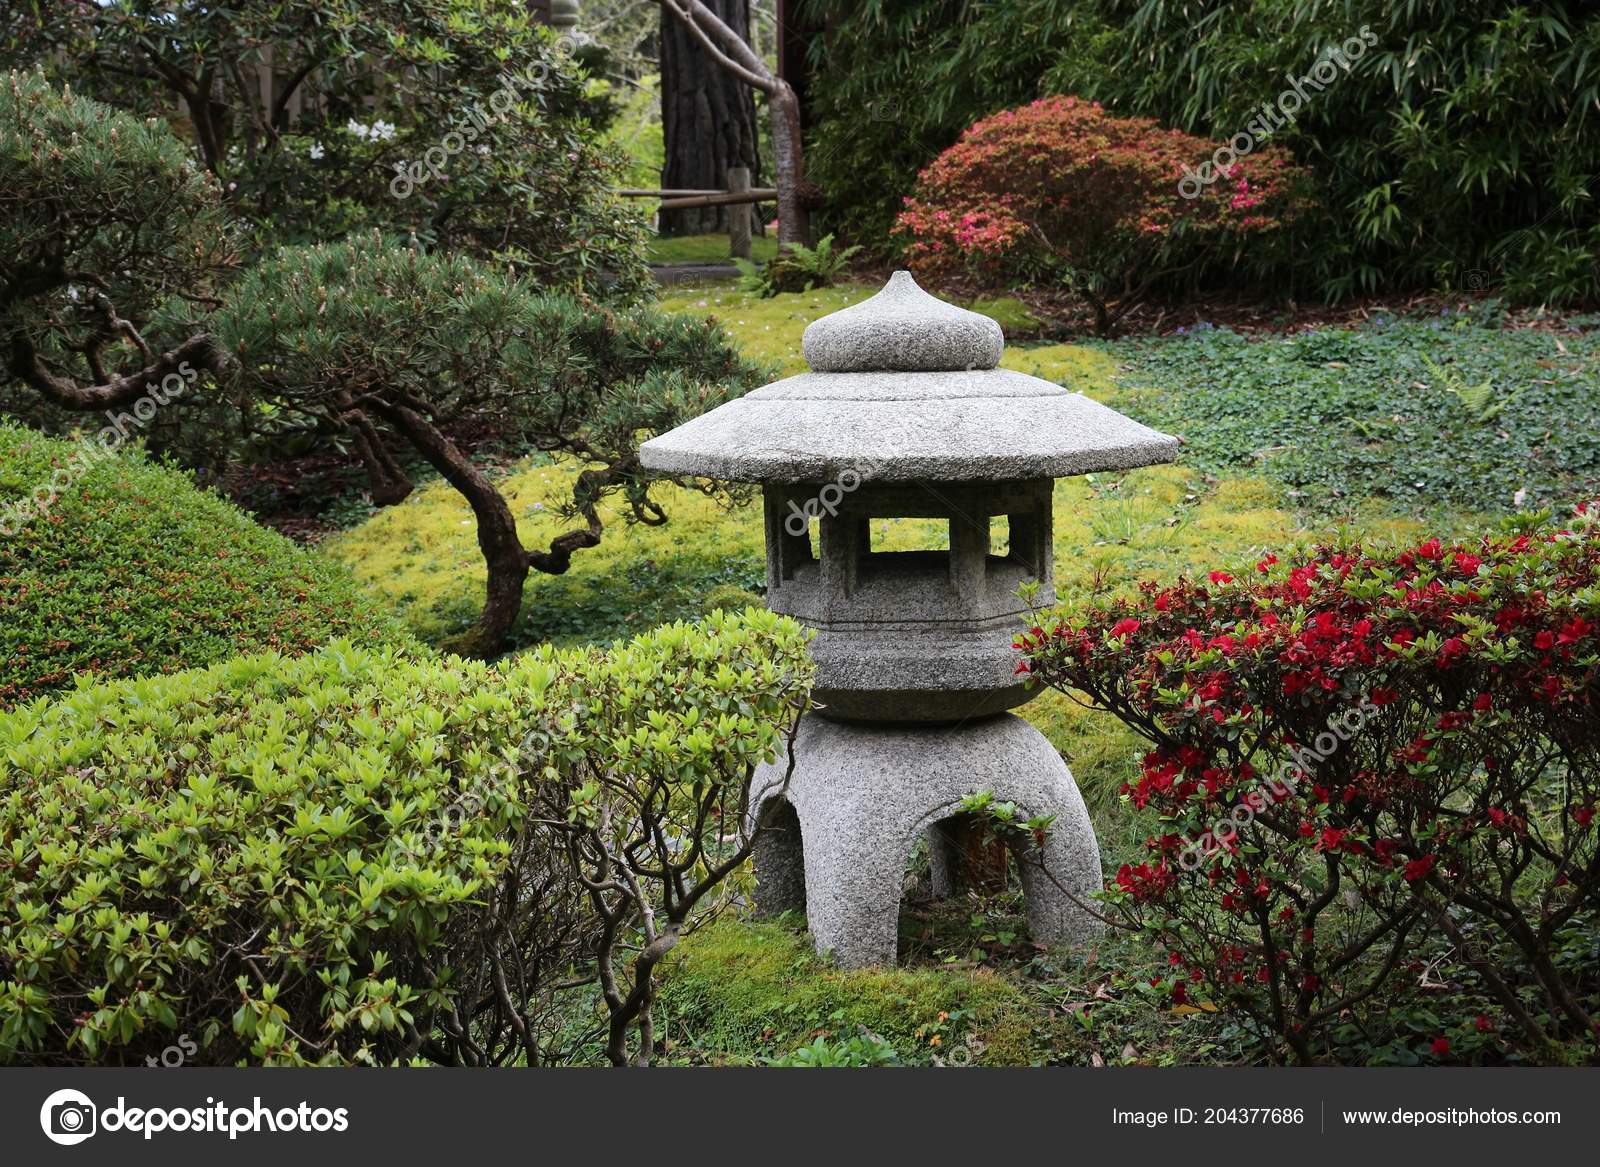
[800,272,1005,373]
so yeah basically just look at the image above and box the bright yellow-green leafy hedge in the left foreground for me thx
[0,608,810,1065]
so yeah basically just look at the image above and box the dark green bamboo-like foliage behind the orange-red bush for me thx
[808,0,1600,304]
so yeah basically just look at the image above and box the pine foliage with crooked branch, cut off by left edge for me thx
[0,72,230,410]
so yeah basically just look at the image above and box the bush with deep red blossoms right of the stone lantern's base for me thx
[1019,514,1600,1063]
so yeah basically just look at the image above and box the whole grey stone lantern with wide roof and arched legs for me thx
[640,272,1178,965]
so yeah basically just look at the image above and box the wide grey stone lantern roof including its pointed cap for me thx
[638,272,1178,483]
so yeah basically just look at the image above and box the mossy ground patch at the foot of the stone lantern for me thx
[658,901,1246,1066]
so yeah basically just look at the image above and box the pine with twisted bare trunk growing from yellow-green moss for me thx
[213,235,760,655]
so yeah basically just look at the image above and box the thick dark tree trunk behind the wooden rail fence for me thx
[661,0,760,235]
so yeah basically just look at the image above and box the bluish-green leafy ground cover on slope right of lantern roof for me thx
[1115,306,1600,522]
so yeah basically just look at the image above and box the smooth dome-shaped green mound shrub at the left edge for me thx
[0,421,410,709]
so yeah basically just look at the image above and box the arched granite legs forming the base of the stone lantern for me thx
[750,714,1101,967]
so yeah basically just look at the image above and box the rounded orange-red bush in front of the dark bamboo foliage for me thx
[896,98,1306,333]
